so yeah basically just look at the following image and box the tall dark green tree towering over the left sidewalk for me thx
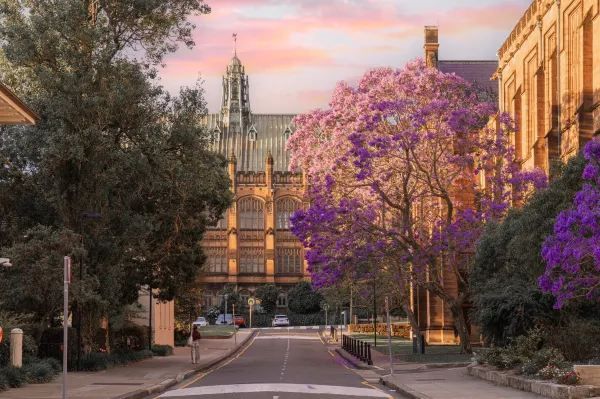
[0,0,231,346]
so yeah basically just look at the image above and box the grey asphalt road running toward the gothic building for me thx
[161,328,398,399]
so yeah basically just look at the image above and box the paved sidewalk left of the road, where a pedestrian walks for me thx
[0,330,252,399]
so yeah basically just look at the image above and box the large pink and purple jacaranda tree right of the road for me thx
[289,60,545,351]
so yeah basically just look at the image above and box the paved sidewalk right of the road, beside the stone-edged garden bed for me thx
[382,363,542,399]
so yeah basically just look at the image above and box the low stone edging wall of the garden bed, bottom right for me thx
[467,365,600,399]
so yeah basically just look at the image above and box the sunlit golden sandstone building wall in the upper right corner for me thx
[496,0,600,172]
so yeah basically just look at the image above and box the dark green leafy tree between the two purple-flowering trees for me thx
[471,157,584,344]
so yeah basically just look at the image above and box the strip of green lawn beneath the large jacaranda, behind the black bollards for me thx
[352,334,471,363]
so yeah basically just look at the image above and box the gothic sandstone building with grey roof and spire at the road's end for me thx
[200,55,310,307]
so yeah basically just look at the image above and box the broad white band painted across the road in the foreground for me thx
[160,384,389,398]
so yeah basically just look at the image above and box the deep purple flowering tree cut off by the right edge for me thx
[539,139,600,309]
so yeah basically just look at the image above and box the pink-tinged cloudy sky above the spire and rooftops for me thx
[161,0,531,113]
